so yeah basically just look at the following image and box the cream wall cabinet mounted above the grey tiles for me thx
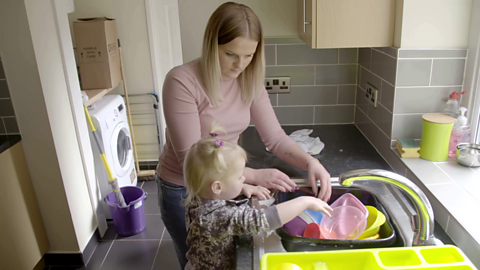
[298,0,395,49]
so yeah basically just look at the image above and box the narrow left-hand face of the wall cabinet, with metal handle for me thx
[298,0,317,48]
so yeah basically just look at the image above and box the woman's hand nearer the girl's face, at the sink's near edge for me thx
[249,169,298,192]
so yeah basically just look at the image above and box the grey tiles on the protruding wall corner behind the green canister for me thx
[355,47,467,148]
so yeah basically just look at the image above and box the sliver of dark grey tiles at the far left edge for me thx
[0,61,20,135]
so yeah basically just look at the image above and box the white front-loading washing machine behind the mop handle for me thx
[88,95,137,219]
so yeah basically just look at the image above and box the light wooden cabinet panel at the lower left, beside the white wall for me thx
[0,142,49,270]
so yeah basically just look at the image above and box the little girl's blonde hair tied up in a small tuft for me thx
[183,125,247,205]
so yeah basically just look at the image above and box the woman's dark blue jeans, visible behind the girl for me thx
[156,175,189,269]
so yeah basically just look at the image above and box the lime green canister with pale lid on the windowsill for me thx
[419,113,455,161]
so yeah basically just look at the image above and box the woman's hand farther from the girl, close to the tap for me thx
[307,158,332,202]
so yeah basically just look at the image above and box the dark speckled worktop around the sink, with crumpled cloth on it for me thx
[236,124,453,270]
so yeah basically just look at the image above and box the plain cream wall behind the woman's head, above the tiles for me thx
[178,0,298,63]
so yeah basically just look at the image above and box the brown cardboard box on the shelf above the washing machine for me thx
[73,17,122,90]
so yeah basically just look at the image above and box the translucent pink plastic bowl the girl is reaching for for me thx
[320,205,367,240]
